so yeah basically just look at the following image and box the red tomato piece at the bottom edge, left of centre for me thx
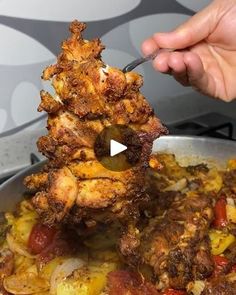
[108,270,159,295]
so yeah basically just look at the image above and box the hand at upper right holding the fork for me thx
[142,0,236,101]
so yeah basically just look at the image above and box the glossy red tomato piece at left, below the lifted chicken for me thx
[28,223,56,254]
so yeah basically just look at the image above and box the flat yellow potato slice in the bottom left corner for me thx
[3,272,49,295]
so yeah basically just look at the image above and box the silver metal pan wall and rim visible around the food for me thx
[0,136,236,212]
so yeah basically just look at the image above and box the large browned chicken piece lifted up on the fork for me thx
[25,21,167,225]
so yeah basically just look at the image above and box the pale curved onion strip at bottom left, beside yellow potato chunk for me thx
[50,258,85,294]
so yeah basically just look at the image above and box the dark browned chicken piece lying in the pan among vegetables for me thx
[120,193,214,290]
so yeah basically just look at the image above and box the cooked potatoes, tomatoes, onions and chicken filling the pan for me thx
[0,154,236,295]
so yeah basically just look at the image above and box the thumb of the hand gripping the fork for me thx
[153,4,217,49]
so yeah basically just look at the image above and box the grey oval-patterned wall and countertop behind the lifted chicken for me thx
[0,0,236,178]
